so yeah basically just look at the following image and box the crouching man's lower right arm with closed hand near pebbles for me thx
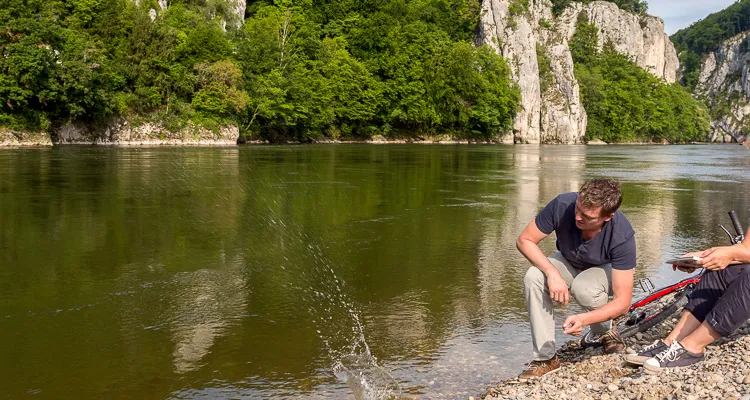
[563,269,635,336]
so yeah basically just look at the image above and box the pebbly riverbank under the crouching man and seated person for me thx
[470,319,750,400]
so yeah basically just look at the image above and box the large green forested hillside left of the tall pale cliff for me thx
[0,0,518,140]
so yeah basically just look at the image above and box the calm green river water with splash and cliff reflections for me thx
[0,145,750,399]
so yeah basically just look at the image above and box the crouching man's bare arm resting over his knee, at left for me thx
[516,219,570,305]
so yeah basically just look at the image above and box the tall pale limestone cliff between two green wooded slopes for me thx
[478,0,679,144]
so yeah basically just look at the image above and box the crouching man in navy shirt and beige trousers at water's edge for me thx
[516,179,636,382]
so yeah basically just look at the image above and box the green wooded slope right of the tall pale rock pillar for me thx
[571,17,709,142]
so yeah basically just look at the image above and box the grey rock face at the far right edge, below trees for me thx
[695,32,750,142]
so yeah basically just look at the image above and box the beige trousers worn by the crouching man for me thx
[523,253,612,361]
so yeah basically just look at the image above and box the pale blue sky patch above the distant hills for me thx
[648,0,736,35]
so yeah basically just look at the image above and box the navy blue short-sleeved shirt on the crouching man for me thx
[535,192,636,270]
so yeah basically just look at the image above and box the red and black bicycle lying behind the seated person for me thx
[581,211,745,348]
